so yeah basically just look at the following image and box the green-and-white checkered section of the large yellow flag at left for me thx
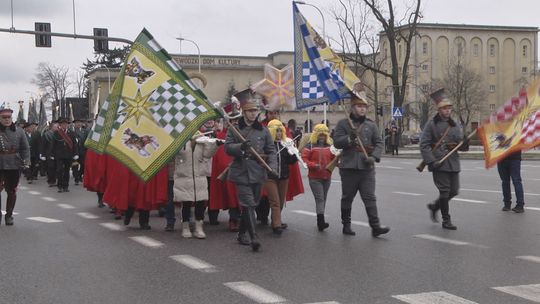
[150,80,207,137]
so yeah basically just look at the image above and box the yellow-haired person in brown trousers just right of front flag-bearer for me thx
[264,119,298,235]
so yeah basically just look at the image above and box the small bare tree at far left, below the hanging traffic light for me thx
[32,62,71,117]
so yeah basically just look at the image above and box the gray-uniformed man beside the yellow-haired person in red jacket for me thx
[334,92,390,237]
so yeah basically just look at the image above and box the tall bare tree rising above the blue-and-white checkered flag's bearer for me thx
[333,0,422,107]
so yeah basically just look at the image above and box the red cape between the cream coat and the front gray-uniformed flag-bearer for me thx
[208,128,238,210]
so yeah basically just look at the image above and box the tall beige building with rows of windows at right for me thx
[379,23,538,129]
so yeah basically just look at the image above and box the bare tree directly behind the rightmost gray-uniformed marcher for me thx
[441,56,487,129]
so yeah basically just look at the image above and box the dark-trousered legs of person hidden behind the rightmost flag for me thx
[497,150,525,213]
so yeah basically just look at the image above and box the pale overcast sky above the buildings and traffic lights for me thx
[0,0,540,113]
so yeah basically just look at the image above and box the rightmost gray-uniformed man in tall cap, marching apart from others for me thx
[420,89,468,230]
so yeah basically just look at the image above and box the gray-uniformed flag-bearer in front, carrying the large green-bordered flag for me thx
[225,89,276,251]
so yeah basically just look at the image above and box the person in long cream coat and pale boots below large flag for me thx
[169,133,218,239]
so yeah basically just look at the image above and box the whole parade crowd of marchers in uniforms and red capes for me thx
[0,89,524,251]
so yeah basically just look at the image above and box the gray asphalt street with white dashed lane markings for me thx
[0,158,540,304]
